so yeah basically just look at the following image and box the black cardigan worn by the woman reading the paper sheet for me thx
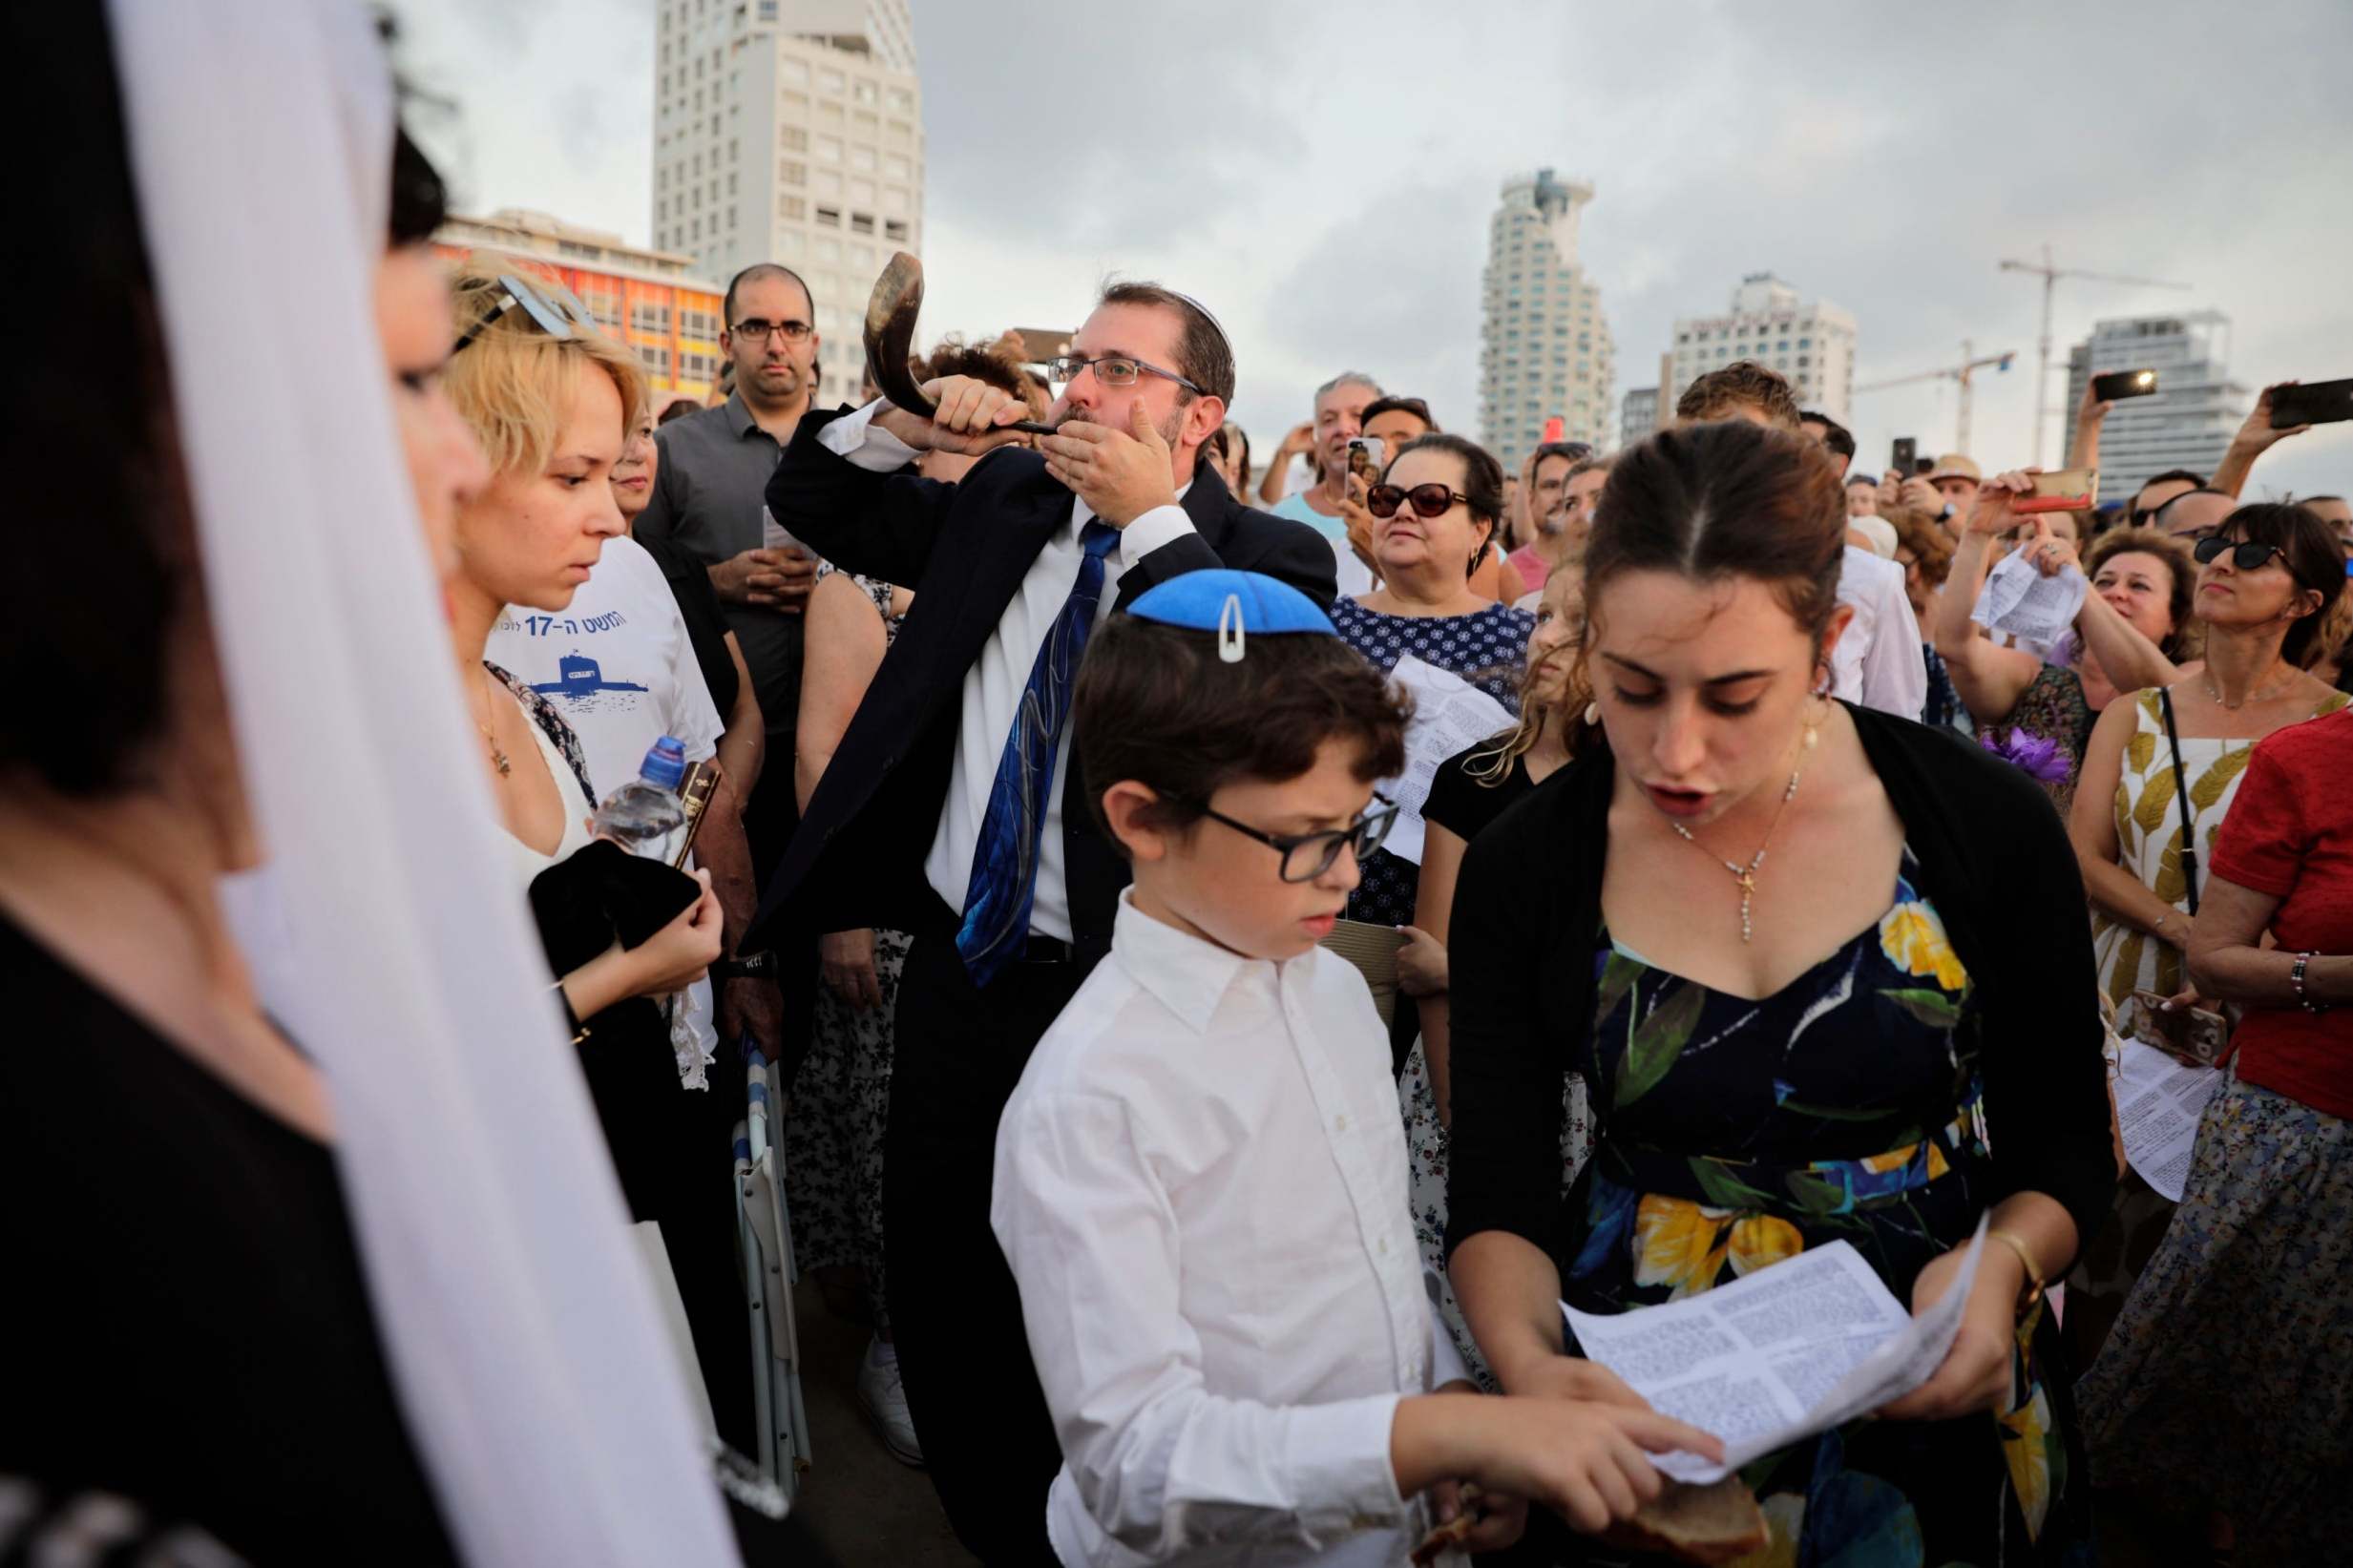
[1447,705,2115,1274]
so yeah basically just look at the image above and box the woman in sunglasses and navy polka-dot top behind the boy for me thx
[1332,432,1537,968]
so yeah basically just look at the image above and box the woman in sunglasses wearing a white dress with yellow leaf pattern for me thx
[2066,506,2353,1366]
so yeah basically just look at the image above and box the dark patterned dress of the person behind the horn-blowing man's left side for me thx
[784,562,913,1330]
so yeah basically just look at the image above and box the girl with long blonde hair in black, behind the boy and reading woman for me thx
[1397,564,1590,1370]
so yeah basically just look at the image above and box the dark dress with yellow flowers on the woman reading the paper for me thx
[1565,856,2091,1568]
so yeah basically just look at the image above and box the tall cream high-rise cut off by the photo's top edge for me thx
[654,0,922,402]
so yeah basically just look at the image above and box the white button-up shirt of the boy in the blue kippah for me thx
[988,889,1463,1568]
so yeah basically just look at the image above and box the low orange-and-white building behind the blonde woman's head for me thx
[433,207,723,409]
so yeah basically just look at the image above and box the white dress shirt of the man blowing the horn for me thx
[816,400,1193,943]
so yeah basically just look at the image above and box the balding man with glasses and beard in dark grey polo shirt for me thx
[636,261,819,877]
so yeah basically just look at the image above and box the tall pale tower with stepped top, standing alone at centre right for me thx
[1480,169,1616,472]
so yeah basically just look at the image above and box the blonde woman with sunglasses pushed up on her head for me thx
[442,256,753,1451]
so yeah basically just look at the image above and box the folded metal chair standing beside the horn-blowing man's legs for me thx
[734,1051,809,1500]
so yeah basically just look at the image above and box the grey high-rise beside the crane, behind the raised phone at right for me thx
[2066,310,2247,506]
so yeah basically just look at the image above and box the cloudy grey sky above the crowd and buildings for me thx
[393,0,2353,493]
